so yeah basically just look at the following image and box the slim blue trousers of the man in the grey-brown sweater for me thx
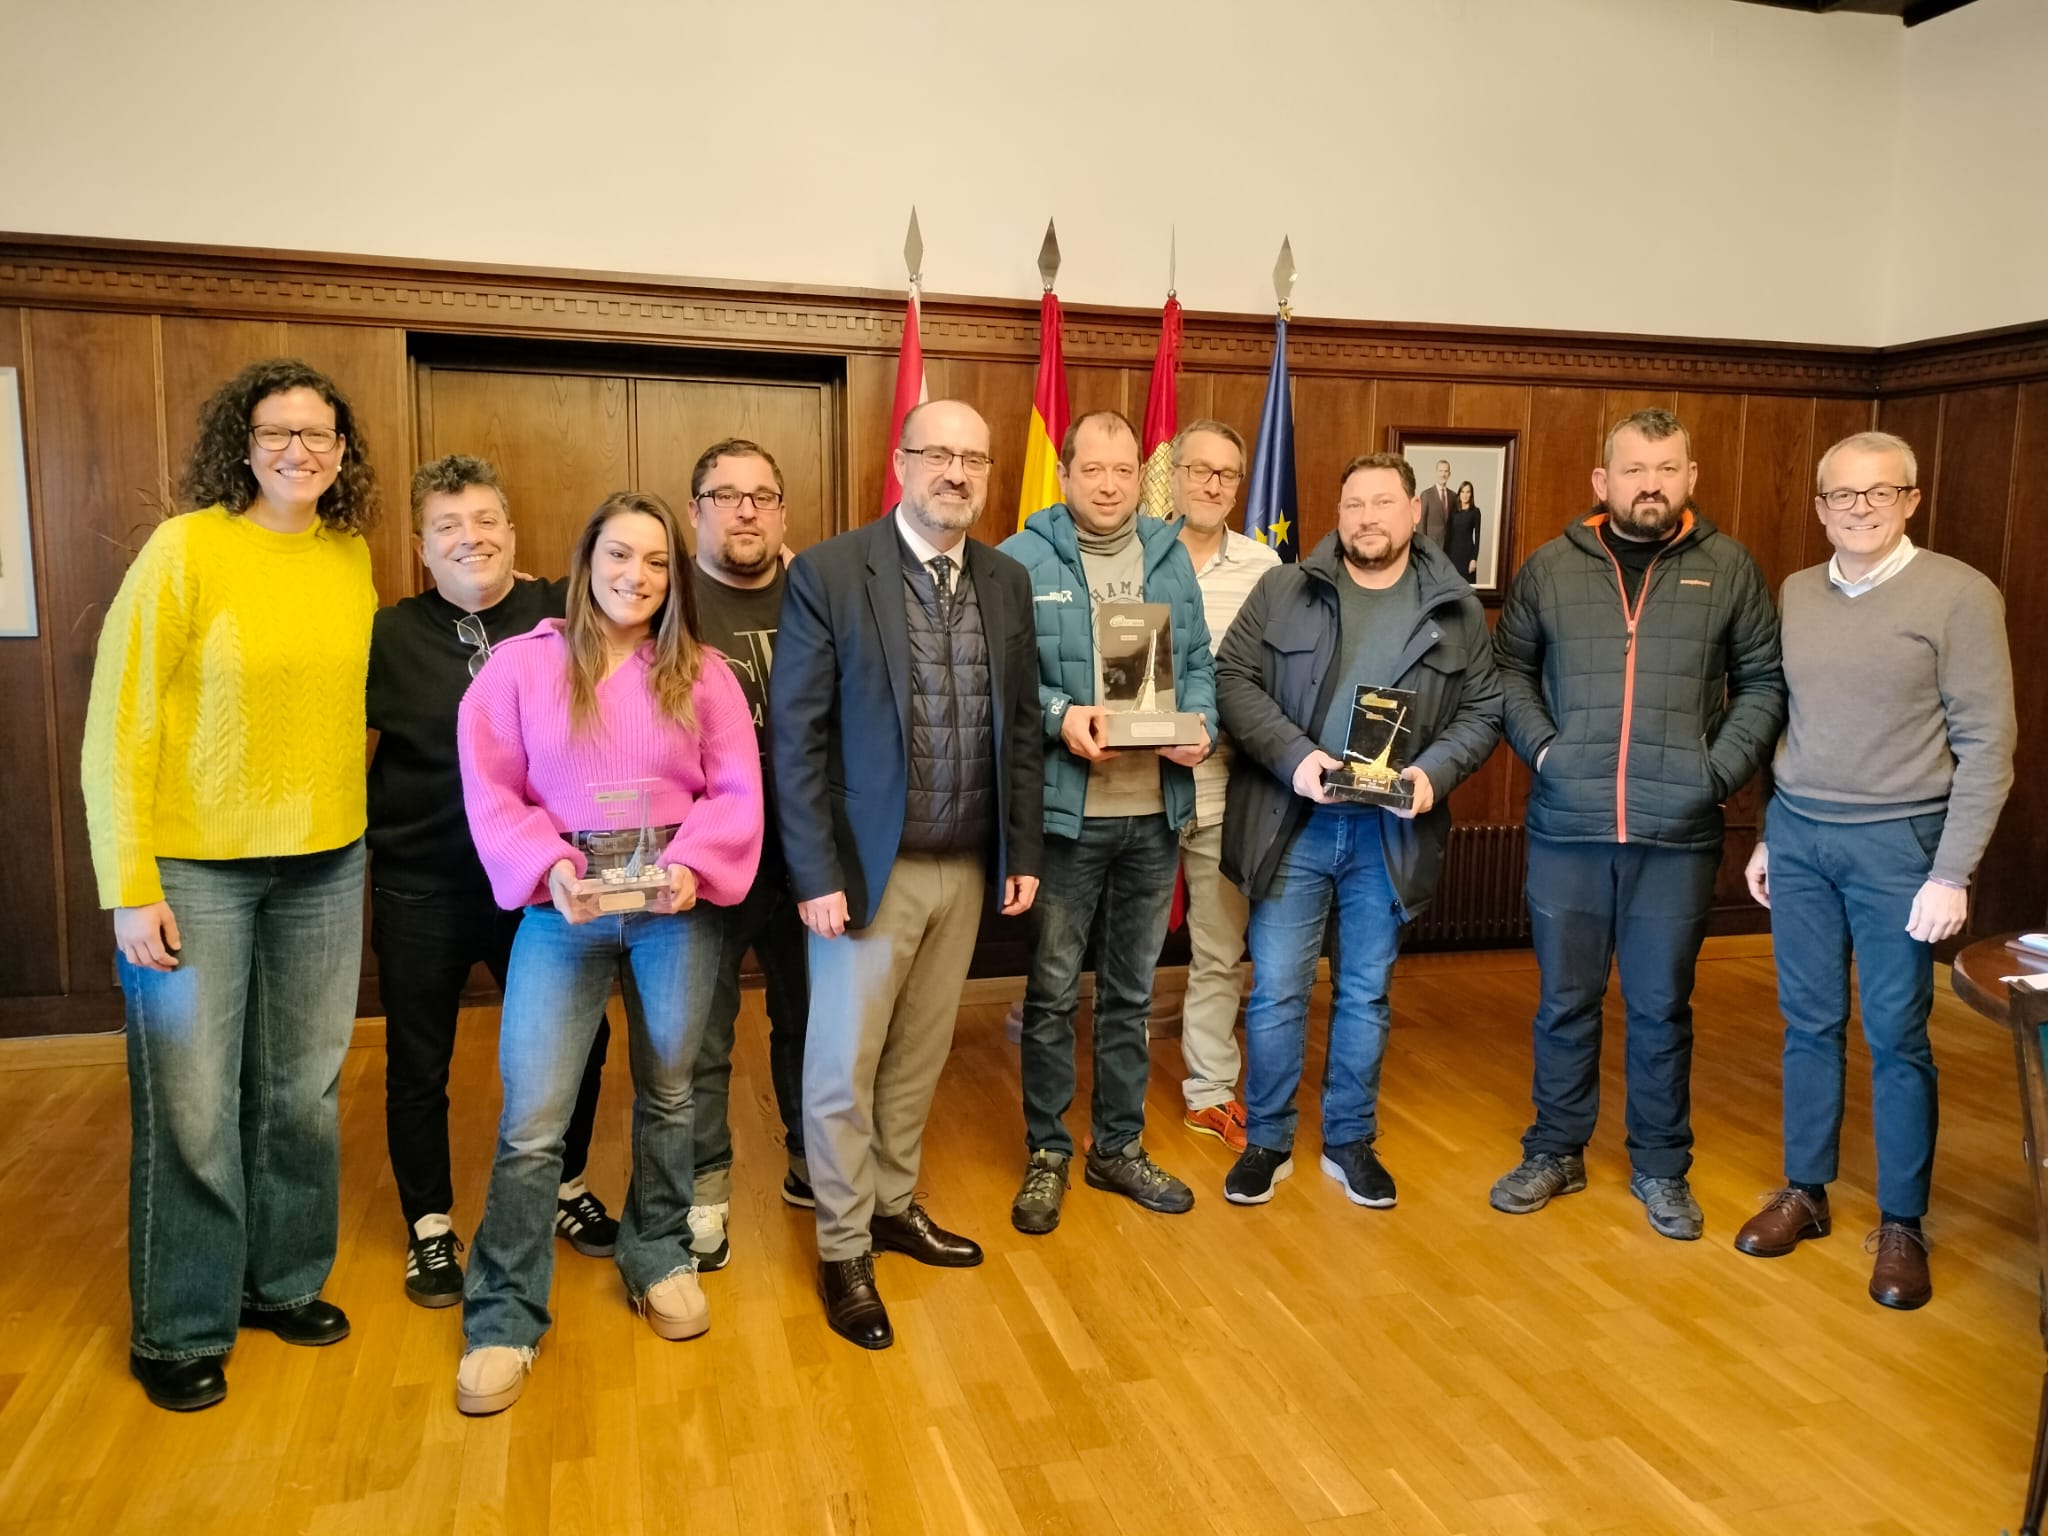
[1767,801,1944,1217]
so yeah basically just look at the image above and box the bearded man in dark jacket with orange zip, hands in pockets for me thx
[1493,410,1786,1239]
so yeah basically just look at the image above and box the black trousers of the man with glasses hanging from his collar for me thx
[371,885,610,1229]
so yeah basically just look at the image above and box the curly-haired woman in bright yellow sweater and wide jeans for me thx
[84,358,377,1409]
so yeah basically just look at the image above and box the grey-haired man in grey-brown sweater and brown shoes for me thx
[1735,432,2017,1309]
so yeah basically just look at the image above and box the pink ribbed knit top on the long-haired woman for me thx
[457,618,762,911]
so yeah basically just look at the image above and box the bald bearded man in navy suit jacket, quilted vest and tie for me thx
[768,399,1044,1350]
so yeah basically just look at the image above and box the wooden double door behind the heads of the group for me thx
[414,358,846,588]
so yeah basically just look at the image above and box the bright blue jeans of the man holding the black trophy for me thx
[1245,805,1401,1151]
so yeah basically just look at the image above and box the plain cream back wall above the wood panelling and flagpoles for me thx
[0,0,1966,344]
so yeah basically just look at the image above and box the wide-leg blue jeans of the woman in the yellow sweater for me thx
[121,840,362,1360]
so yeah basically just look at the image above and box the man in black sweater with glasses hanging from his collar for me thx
[369,455,618,1307]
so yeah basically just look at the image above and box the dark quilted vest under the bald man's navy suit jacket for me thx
[897,545,995,854]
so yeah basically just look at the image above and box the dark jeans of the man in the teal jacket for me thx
[1020,815,1180,1157]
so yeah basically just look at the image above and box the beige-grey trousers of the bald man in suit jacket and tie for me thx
[803,854,985,1262]
